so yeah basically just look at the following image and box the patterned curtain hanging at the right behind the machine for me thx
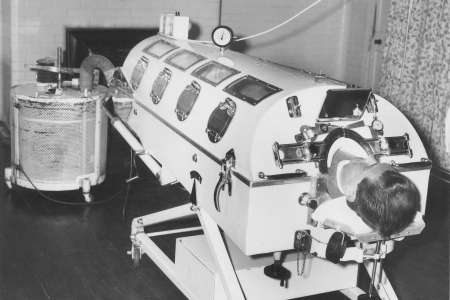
[379,0,450,170]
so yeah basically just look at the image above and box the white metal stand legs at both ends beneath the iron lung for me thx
[128,203,397,300]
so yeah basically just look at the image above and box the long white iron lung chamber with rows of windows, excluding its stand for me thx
[121,35,431,255]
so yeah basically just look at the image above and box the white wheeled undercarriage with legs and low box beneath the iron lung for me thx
[129,204,397,300]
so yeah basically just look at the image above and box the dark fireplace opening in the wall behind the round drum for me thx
[65,28,158,68]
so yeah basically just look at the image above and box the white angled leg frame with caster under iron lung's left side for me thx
[129,204,245,300]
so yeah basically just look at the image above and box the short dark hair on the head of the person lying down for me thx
[355,170,420,238]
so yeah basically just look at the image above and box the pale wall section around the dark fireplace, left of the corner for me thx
[6,0,218,84]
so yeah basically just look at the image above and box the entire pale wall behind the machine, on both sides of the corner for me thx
[0,0,387,124]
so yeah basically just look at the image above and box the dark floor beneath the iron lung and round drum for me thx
[0,135,450,300]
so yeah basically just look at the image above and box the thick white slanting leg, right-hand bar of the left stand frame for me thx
[197,210,245,300]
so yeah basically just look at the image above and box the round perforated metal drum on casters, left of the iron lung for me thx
[11,84,108,191]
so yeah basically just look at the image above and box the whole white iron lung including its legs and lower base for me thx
[108,35,431,299]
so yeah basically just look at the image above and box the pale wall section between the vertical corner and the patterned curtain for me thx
[222,0,375,85]
